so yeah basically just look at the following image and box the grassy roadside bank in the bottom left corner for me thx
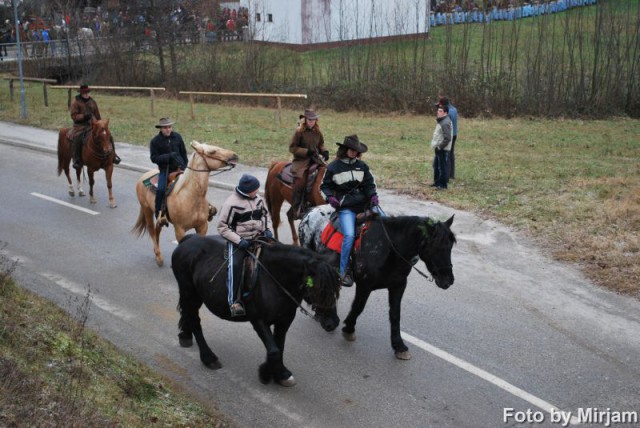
[0,258,232,428]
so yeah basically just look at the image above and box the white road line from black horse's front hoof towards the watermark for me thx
[400,331,580,425]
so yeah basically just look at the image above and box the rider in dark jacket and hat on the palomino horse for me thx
[149,117,188,225]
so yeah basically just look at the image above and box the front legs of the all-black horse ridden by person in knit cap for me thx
[251,313,296,386]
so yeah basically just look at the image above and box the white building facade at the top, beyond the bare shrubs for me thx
[223,0,430,45]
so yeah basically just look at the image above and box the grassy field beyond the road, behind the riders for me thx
[0,85,640,298]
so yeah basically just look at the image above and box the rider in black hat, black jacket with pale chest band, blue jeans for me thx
[320,135,378,287]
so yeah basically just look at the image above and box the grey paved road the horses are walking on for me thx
[0,122,640,427]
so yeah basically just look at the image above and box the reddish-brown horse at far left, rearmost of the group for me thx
[58,119,116,208]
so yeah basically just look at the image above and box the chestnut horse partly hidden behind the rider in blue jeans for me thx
[264,161,327,245]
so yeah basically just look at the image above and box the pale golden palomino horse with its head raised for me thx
[131,141,238,266]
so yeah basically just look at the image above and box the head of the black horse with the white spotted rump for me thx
[418,216,456,290]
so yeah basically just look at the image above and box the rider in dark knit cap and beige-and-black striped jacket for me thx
[218,174,273,317]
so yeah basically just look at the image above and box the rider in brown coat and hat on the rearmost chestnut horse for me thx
[69,85,120,168]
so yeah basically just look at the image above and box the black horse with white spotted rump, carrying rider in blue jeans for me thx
[298,206,456,360]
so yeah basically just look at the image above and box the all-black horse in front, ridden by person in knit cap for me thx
[171,235,340,386]
